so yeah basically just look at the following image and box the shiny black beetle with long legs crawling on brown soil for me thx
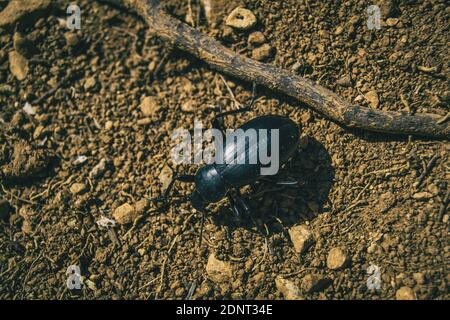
[152,85,300,243]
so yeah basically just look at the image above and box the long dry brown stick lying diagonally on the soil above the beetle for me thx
[103,0,450,139]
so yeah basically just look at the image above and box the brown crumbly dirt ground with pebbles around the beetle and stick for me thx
[0,0,450,299]
